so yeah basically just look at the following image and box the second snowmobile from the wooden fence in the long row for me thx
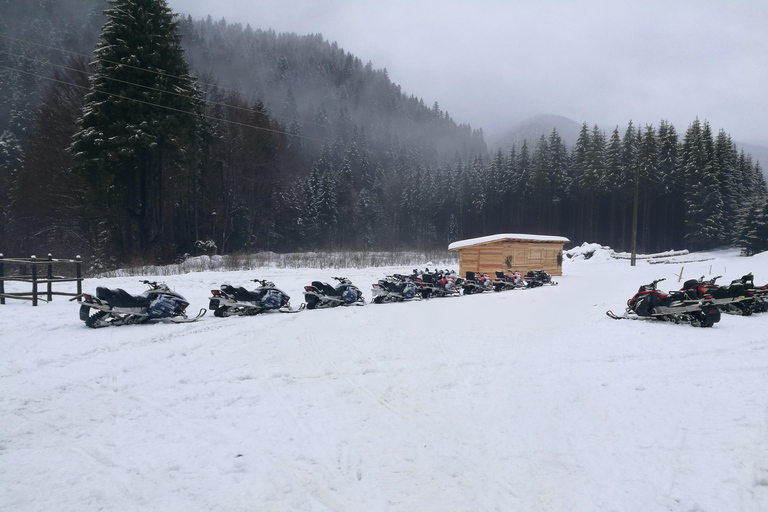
[208,279,304,317]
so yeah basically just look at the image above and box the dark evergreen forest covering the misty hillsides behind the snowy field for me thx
[0,0,768,268]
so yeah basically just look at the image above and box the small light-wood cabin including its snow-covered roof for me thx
[448,233,570,276]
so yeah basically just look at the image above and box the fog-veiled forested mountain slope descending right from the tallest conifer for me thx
[180,17,487,163]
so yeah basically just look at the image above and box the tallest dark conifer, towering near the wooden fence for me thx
[72,0,198,258]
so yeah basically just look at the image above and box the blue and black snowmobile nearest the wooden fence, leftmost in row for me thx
[77,281,206,328]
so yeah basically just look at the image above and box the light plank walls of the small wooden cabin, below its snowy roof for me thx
[459,240,563,276]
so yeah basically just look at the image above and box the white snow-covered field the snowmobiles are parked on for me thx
[0,251,768,512]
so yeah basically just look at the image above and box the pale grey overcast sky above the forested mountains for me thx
[168,0,768,145]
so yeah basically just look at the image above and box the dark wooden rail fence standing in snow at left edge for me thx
[0,254,83,306]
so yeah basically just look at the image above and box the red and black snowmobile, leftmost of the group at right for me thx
[606,278,720,327]
